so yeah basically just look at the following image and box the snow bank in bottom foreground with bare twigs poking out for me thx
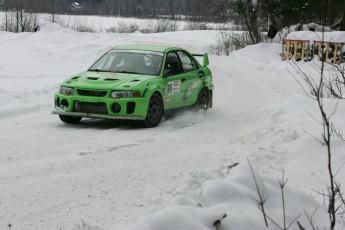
[120,165,328,230]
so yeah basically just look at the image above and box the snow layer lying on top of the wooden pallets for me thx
[286,31,345,43]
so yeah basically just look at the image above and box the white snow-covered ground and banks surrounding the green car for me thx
[0,24,345,230]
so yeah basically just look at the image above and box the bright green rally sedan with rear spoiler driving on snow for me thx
[52,45,213,127]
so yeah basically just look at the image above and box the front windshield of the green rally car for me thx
[89,50,163,76]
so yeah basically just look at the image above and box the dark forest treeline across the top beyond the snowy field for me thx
[0,0,345,27]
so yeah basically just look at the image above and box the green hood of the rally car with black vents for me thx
[63,71,157,90]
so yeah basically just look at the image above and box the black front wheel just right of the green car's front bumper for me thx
[144,94,164,128]
